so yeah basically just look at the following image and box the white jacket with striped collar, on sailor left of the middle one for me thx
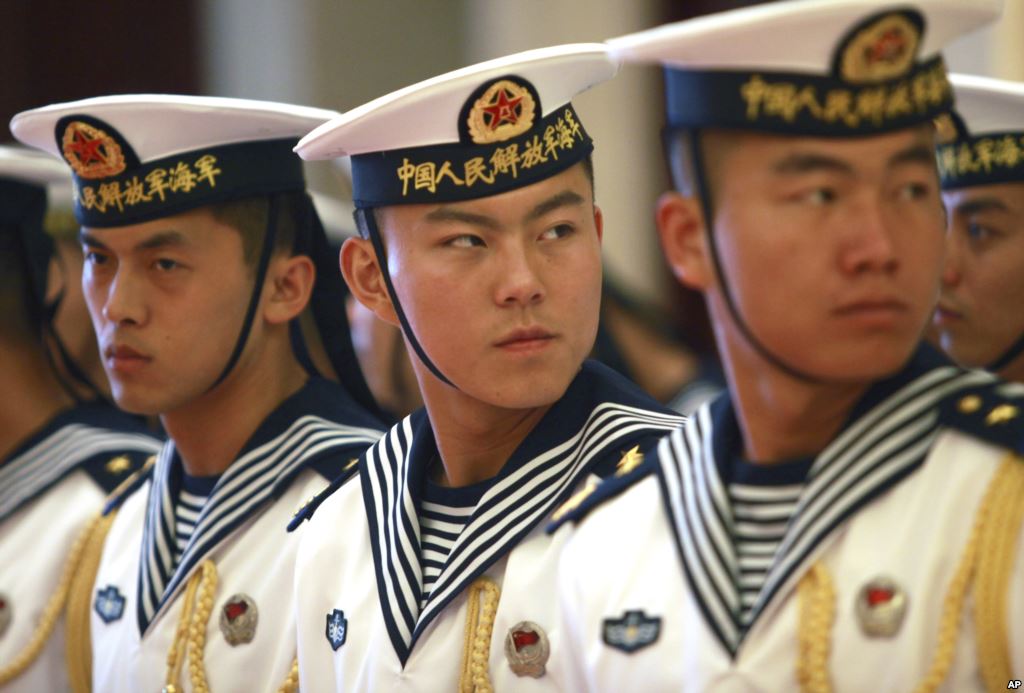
[91,378,381,693]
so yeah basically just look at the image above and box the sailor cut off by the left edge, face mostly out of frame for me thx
[0,146,160,693]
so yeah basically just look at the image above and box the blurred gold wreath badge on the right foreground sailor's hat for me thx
[840,14,921,84]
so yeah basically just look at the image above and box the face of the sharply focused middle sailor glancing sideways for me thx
[380,165,601,408]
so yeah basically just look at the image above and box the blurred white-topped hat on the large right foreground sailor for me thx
[608,0,1002,136]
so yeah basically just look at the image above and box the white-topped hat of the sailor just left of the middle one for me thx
[10,94,338,226]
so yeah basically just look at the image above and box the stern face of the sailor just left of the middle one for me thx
[82,209,253,415]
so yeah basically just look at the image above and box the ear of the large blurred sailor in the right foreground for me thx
[655,192,715,291]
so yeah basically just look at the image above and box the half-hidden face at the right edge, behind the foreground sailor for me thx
[935,178,1024,366]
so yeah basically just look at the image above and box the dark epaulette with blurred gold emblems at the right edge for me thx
[939,381,1024,454]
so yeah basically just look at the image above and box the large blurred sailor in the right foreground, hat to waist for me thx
[552,0,1024,691]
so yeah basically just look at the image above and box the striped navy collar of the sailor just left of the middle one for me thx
[137,378,382,634]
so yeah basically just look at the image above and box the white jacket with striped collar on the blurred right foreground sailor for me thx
[551,349,1024,693]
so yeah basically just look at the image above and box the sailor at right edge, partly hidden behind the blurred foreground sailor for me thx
[935,75,1024,383]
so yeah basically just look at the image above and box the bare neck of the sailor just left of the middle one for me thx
[160,343,306,476]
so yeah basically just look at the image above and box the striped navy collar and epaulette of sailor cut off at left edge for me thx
[0,402,161,522]
